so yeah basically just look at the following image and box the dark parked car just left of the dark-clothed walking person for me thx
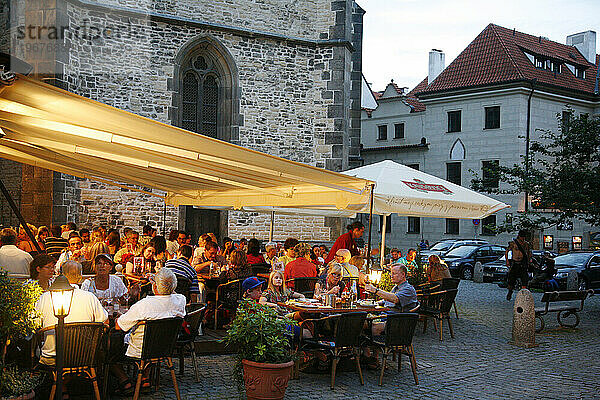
[442,244,506,280]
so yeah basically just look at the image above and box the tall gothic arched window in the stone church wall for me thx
[181,55,220,138]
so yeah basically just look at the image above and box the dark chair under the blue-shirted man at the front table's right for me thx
[371,313,419,386]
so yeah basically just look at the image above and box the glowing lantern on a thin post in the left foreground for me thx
[48,275,73,399]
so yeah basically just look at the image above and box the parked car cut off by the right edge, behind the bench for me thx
[554,251,600,290]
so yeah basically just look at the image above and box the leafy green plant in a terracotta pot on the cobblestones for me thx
[224,300,294,399]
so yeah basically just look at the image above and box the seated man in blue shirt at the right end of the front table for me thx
[365,264,419,335]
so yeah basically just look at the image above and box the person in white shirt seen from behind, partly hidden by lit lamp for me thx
[36,261,108,365]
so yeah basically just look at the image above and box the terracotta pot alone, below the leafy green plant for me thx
[242,360,294,400]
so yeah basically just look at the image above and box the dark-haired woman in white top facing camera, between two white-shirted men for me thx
[81,254,128,304]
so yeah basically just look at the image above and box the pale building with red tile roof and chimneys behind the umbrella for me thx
[361,24,600,258]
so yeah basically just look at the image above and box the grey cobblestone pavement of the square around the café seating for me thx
[143,281,600,400]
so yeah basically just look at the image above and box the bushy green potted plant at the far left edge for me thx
[0,271,42,399]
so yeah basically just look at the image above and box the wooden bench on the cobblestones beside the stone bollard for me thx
[535,290,594,333]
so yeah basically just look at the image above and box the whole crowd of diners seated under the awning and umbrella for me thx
[0,221,449,392]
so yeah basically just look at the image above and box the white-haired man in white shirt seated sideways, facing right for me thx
[115,268,186,358]
